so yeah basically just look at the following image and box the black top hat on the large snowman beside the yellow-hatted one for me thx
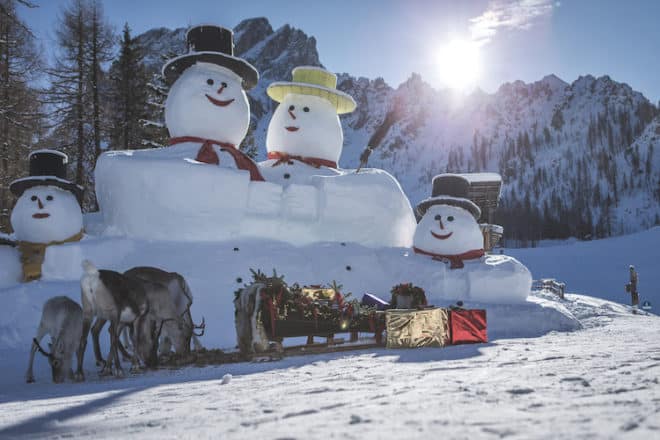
[163,25,259,90]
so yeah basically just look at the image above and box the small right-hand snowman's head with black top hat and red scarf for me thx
[413,174,484,269]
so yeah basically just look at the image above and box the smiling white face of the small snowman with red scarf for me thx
[413,205,484,255]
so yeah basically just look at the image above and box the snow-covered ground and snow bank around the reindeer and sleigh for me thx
[0,227,660,439]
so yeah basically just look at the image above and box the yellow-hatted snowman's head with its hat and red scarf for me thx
[259,66,356,186]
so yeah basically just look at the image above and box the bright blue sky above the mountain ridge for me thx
[20,0,660,103]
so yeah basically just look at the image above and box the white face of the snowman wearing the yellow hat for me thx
[266,93,344,162]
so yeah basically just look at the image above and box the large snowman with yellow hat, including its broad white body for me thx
[259,66,416,246]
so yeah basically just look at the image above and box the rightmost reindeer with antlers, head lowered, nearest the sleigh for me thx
[124,266,206,354]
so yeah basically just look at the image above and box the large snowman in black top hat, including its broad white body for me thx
[95,25,263,240]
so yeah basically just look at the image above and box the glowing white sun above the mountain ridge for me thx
[437,40,480,90]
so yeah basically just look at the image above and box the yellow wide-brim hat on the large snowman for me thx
[266,66,357,115]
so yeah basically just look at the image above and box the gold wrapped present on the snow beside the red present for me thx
[385,308,449,348]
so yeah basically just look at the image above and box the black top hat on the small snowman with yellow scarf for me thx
[9,150,83,203]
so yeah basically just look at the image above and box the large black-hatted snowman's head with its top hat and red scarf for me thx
[163,25,263,181]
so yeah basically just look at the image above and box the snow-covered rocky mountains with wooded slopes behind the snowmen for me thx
[139,18,660,245]
